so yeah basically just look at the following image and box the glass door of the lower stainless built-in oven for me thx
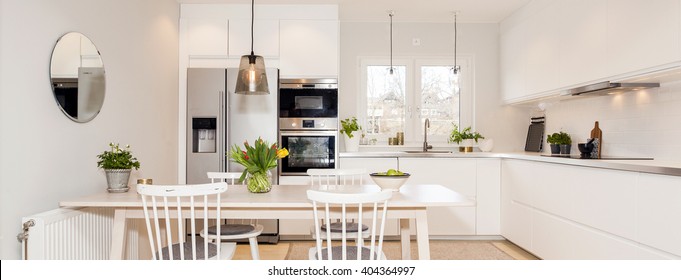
[279,131,338,175]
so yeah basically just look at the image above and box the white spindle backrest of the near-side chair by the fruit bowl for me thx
[307,190,393,260]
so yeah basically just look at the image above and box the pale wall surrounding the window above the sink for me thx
[339,21,529,152]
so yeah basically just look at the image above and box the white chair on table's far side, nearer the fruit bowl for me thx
[307,168,369,239]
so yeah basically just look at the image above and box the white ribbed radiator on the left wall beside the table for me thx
[22,207,139,260]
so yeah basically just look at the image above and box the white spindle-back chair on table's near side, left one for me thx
[137,183,236,260]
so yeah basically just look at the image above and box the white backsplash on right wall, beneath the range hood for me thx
[544,81,681,161]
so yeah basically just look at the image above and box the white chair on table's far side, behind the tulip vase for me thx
[201,172,263,260]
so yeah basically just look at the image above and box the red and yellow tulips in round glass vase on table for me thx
[229,138,288,193]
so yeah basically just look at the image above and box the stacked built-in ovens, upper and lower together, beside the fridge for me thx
[279,79,338,176]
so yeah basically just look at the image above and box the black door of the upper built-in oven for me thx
[279,88,338,118]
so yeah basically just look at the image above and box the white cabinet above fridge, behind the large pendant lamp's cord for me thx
[229,19,279,58]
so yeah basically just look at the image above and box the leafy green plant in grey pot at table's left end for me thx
[97,143,140,193]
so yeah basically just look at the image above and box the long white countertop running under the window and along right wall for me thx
[339,151,681,176]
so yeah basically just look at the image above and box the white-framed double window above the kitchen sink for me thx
[358,58,472,144]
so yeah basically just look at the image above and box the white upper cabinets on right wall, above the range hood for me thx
[500,0,681,103]
